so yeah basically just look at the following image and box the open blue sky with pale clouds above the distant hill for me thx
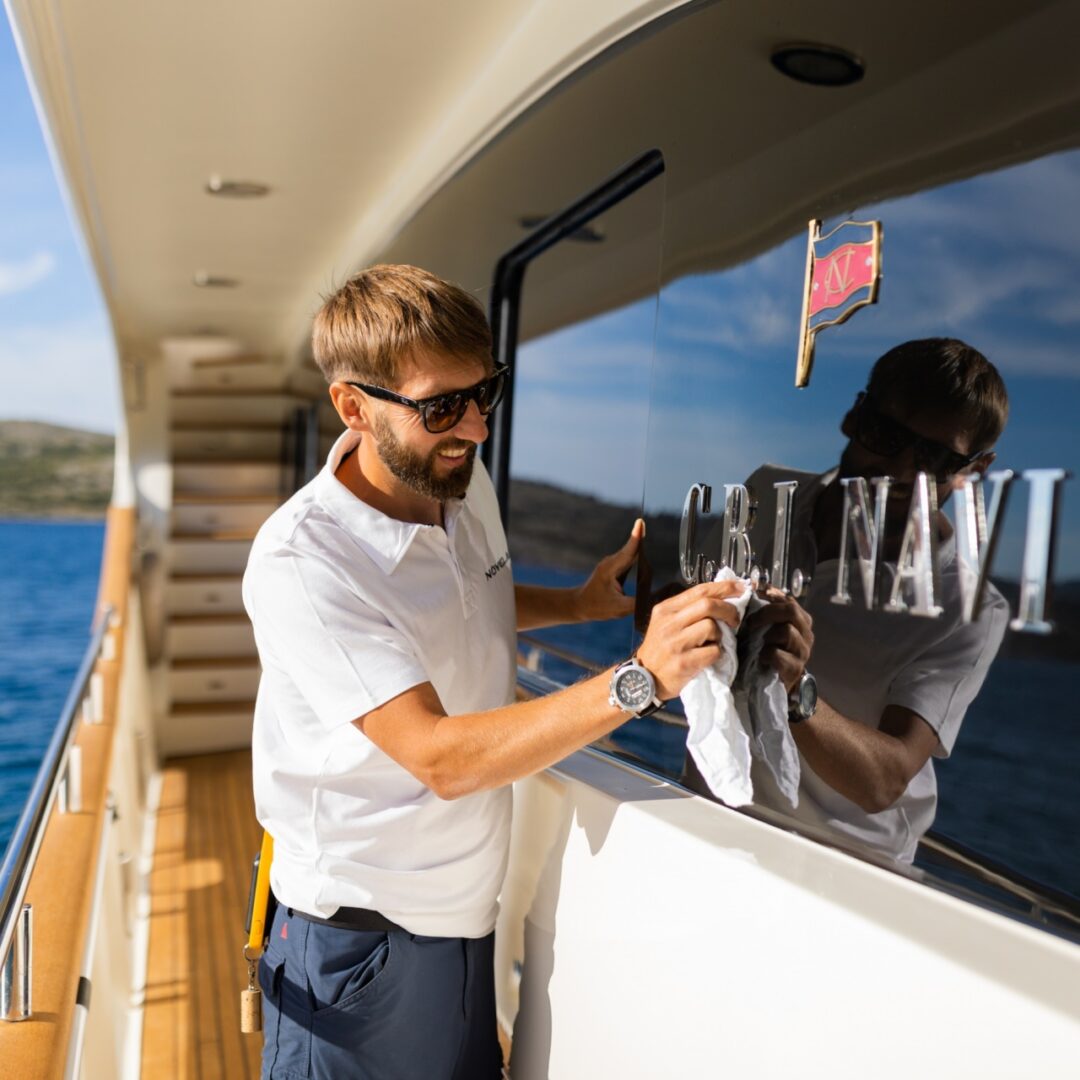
[0,16,119,433]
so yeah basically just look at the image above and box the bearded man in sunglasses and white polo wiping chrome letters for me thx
[244,266,734,1080]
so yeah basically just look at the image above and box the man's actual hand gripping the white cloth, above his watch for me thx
[637,581,746,701]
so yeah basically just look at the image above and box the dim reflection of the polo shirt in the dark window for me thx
[747,465,1009,862]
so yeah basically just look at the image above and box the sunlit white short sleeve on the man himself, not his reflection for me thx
[244,552,428,729]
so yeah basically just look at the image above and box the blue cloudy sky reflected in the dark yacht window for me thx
[515,152,1080,579]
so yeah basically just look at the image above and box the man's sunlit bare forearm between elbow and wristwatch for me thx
[424,671,626,798]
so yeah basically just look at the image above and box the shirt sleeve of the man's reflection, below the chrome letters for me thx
[887,590,1009,757]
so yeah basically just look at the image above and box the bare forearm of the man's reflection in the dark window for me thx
[792,701,910,813]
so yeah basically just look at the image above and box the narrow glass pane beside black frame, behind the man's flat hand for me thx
[510,177,663,751]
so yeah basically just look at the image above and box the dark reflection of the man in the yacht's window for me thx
[747,338,1009,862]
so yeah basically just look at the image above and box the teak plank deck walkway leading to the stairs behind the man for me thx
[143,751,262,1080]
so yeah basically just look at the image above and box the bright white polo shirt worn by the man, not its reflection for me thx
[243,432,516,937]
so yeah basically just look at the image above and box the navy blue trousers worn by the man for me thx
[259,907,502,1080]
